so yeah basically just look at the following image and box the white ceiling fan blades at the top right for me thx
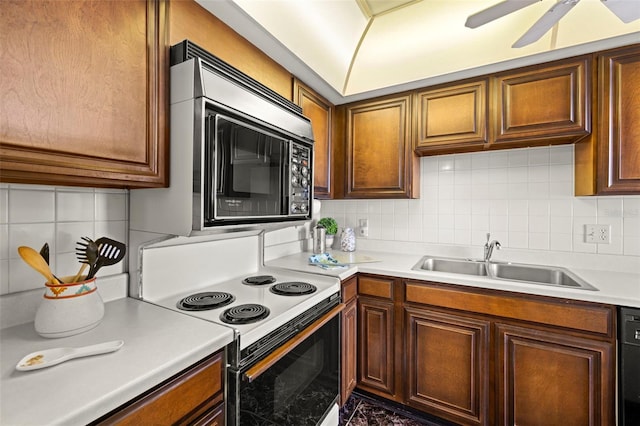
[465,0,640,47]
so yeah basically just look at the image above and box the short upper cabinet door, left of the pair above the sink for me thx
[414,79,489,155]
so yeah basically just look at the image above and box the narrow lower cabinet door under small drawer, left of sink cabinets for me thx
[358,296,396,399]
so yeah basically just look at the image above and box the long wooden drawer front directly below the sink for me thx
[406,281,615,338]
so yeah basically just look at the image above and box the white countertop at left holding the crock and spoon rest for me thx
[0,298,233,426]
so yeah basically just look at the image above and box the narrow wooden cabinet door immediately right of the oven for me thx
[340,299,358,406]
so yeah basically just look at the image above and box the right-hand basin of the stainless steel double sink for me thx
[488,263,596,290]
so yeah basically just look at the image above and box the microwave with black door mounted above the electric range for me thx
[130,40,313,236]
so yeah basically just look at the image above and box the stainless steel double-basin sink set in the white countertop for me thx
[412,256,598,291]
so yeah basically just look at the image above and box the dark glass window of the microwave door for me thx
[215,115,288,218]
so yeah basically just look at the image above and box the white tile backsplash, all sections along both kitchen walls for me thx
[0,145,640,294]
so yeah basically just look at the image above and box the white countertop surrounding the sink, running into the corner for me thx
[266,250,640,307]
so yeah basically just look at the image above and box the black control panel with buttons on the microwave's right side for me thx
[289,142,312,215]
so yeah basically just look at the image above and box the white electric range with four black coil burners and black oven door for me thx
[130,234,344,426]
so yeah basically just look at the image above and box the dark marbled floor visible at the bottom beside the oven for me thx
[340,392,450,426]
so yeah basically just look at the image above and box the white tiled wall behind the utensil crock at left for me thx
[0,184,129,294]
